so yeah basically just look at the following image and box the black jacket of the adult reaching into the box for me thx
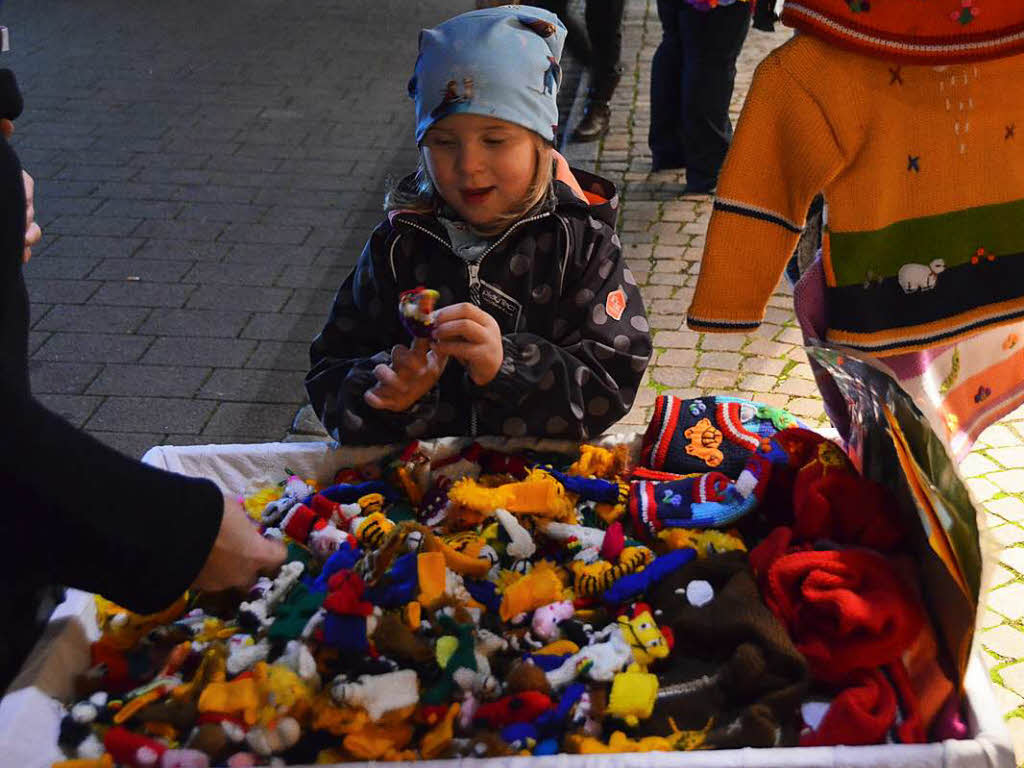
[0,111,223,692]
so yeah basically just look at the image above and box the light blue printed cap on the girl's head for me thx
[409,5,565,144]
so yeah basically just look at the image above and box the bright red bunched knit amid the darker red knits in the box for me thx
[764,550,925,683]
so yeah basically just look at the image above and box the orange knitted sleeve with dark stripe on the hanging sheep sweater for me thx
[686,49,845,333]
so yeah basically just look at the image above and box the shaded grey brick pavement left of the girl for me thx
[0,0,469,456]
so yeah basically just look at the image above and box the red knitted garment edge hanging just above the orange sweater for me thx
[782,0,1024,65]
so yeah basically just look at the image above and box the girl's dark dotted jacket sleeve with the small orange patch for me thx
[479,217,651,439]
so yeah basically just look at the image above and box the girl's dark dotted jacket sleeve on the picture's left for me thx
[306,223,439,444]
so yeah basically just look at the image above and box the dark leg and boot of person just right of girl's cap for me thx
[570,0,626,141]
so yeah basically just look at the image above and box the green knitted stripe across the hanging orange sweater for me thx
[828,200,1024,286]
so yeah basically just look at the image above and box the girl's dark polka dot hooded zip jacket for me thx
[306,170,651,444]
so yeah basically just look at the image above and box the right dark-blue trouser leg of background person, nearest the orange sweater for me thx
[680,2,751,191]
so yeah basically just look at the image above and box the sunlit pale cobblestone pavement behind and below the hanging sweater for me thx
[566,0,1024,764]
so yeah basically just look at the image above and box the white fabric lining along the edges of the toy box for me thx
[0,435,1016,768]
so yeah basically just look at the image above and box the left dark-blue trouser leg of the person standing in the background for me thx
[647,0,686,171]
